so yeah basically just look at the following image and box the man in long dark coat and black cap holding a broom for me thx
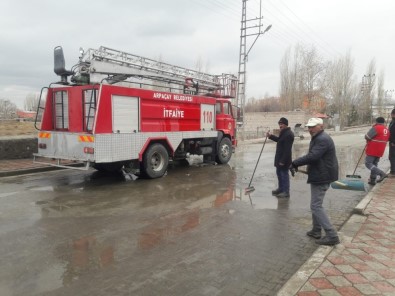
[266,117,294,197]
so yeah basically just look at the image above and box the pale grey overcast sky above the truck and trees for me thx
[0,0,395,108]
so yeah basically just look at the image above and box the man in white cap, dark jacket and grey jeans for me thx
[291,118,340,246]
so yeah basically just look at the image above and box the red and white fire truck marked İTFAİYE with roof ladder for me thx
[34,46,237,178]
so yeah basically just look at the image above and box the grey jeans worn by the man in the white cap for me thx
[310,183,337,237]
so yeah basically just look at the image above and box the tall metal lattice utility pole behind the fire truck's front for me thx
[236,0,272,137]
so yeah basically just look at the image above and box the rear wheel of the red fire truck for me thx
[142,143,169,179]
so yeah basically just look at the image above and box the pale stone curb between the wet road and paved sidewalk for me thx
[277,171,389,296]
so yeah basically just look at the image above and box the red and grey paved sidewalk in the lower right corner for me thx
[278,177,395,296]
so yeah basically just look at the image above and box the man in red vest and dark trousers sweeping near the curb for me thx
[365,117,390,185]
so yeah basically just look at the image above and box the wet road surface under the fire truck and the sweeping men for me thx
[0,135,389,295]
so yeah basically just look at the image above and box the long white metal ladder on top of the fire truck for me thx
[78,46,238,98]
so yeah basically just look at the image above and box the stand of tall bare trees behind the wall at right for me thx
[280,44,392,128]
